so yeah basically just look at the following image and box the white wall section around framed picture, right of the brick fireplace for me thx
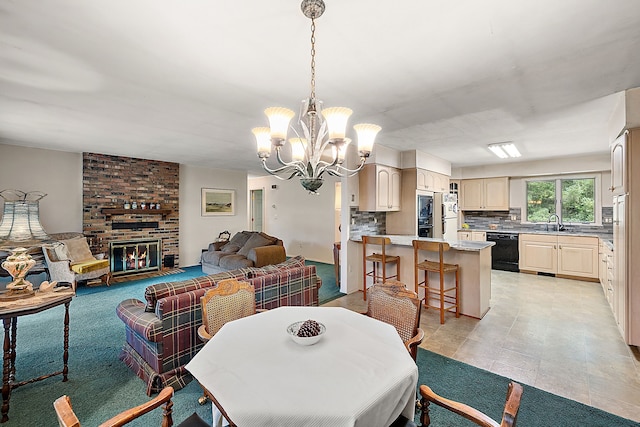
[180,165,249,266]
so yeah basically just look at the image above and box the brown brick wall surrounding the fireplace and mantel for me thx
[82,153,180,267]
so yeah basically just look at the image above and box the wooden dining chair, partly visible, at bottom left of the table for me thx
[53,386,209,427]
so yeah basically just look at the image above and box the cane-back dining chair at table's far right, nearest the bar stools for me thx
[365,280,424,360]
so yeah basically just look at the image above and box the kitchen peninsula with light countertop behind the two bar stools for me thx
[351,235,495,319]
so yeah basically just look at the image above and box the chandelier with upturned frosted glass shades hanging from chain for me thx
[252,0,381,194]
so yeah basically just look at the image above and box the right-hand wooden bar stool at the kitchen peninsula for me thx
[413,240,460,324]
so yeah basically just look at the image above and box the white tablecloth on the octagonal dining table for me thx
[187,307,418,427]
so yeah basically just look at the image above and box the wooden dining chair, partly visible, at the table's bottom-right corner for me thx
[420,381,523,427]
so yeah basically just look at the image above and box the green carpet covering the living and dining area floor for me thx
[4,265,638,427]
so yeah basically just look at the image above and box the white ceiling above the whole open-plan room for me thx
[0,0,640,173]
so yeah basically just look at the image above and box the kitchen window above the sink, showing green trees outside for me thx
[527,178,596,223]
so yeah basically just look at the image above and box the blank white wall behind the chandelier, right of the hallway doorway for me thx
[248,176,336,264]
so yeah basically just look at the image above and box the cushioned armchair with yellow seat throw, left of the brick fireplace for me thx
[42,237,111,289]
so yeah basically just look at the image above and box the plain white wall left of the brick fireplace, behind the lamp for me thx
[0,144,82,234]
